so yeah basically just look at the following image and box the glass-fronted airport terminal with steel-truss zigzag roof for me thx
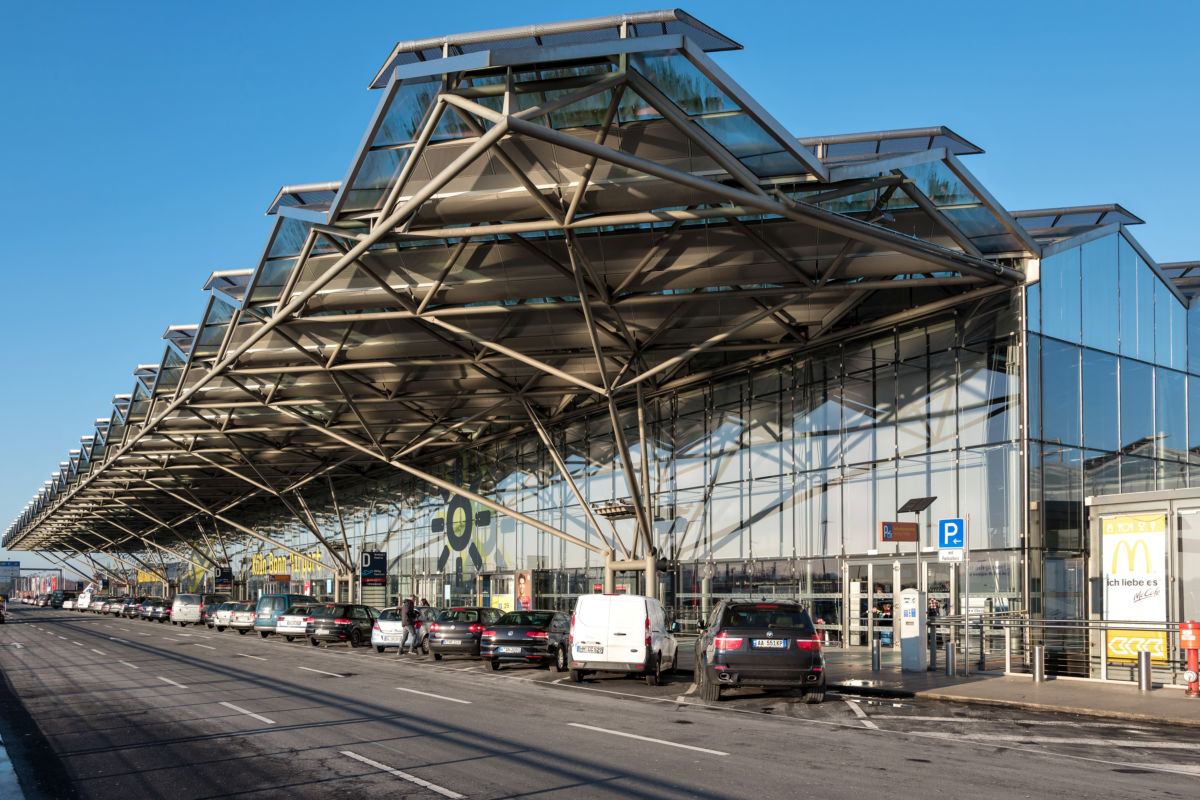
[4,11,1200,662]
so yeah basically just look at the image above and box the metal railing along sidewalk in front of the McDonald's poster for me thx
[929,612,1187,686]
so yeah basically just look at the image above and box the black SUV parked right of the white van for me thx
[696,600,826,703]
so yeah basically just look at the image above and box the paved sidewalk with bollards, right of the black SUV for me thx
[824,648,1200,727]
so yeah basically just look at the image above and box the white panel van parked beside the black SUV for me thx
[571,595,678,686]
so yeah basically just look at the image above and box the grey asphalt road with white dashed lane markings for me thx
[0,606,1200,800]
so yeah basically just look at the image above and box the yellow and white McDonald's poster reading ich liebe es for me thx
[1100,513,1169,663]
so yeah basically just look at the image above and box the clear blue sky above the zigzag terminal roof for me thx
[0,0,1200,566]
